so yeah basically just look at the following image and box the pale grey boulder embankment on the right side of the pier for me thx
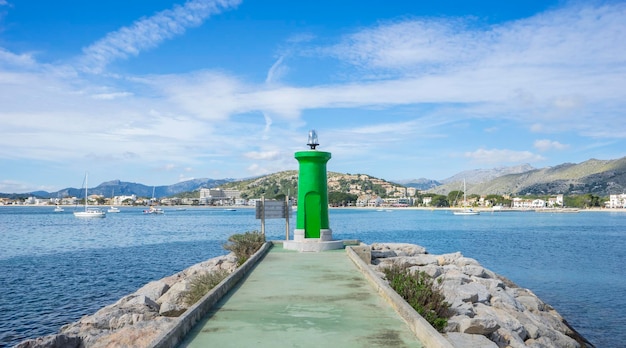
[371,243,593,348]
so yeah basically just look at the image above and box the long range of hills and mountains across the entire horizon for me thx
[0,157,626,198]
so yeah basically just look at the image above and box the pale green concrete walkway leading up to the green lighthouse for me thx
[180,245,422,347]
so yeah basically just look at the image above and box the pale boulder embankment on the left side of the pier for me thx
[16,253,237,348]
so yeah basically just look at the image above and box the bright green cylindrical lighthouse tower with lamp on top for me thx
[294,131,332,241]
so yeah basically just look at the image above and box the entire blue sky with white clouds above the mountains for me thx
[0,0,626,192]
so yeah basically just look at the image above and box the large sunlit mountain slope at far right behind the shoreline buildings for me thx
[429,157,626,196]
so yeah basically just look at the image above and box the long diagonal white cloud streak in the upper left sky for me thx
[81,0,241,73]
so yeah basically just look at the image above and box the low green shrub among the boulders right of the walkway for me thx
[382,265,451,332]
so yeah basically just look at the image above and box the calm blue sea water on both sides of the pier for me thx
[0,207,626,347]
